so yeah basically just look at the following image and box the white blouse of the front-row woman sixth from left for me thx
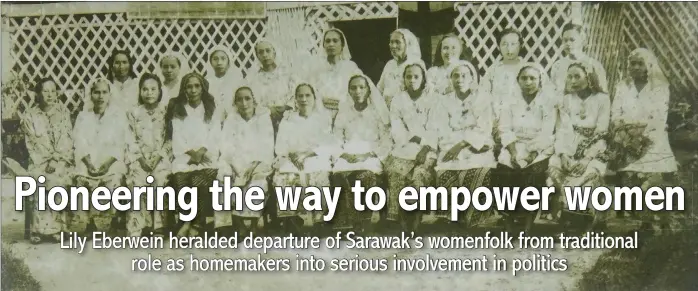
[275,109,337,173]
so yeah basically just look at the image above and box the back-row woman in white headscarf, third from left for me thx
[206,45,243,112]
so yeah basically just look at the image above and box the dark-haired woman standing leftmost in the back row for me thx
[107,49,138,112]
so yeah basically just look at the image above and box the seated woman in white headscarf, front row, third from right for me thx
[493,63,558,232]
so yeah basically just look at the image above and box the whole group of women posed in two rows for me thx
[22,24,676,241]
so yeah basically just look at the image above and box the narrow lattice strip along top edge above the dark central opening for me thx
[307,2,399,53]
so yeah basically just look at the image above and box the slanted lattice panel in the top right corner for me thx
[623,2,698,94]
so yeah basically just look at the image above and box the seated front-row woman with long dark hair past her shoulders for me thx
[165,73,221,236]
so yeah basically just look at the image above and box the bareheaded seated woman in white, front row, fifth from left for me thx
[215,86,274,232]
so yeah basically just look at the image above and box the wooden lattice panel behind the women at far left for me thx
[3,13,266,118]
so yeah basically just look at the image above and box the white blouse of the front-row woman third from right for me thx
[497,90,558,168]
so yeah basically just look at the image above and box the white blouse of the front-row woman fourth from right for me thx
[432,92,497,170]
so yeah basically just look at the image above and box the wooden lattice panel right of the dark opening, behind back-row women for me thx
[454,2,570,75]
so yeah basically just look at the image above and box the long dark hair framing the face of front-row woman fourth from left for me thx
[165,72,216,139]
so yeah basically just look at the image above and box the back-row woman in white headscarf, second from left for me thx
[156,51,190,106]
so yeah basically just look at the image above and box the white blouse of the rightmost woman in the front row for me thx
[611,82,678,173]
